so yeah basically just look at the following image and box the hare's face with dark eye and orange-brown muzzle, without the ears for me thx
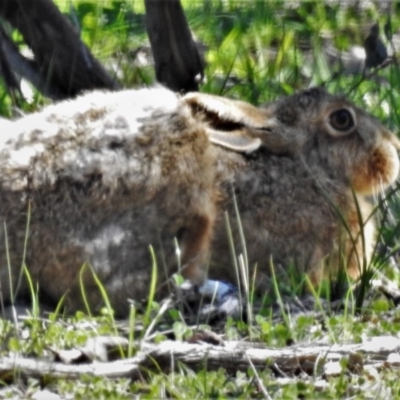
[267,88,400,195]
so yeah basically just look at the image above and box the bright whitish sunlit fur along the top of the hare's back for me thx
[0,87,181,190]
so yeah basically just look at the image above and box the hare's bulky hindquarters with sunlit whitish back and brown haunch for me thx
[0,89,216,313]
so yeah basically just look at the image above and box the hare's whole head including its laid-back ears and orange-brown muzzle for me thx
[185,88,400,195]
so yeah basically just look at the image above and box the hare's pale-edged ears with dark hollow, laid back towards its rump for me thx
[183,93,267,153]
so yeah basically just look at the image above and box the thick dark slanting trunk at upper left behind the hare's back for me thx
[0,0,119,98]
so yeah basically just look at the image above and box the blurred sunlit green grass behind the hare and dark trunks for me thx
[0,0,400,122]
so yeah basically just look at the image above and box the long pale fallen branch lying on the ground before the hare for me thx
[0,336,400,380]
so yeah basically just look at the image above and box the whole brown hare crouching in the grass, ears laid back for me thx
[0,87,400,315]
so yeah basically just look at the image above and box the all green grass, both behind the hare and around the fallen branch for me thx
[0,0,400,399]
